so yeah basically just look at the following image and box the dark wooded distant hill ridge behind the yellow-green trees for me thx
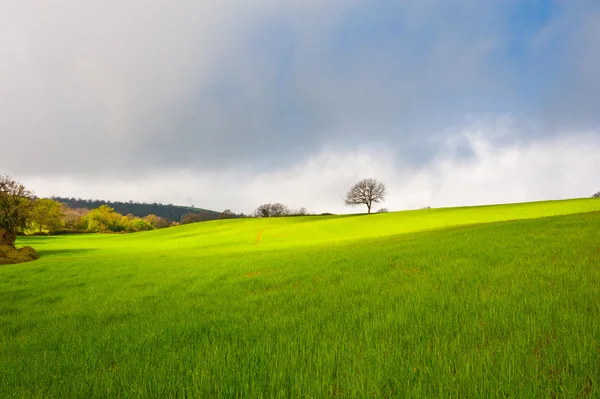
[52,197,220,222]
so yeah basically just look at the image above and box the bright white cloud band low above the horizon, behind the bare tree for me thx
[17,117,600,213]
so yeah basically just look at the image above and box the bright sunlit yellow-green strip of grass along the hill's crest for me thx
[19,199,600,255]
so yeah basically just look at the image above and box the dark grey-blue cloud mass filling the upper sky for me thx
[0,0,600,176]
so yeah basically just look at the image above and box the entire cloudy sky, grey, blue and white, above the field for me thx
[0,0,600,213]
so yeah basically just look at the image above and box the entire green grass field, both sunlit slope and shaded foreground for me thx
[0,199,600,398]
